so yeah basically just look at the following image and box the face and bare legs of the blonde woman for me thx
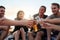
[13,12,25,40]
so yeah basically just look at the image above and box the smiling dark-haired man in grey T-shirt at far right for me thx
[42,3,60,40]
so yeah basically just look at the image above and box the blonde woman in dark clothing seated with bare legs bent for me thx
[13,10,28,40]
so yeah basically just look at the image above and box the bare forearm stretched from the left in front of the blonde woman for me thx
[2,19,25,26]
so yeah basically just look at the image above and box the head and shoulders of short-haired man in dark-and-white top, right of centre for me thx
[33,6,47,20]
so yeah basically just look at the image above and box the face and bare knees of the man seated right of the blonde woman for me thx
[28,7,45,40]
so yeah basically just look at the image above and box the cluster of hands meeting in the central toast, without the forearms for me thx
[24,20,48,28]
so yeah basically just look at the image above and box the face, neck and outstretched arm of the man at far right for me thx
[45,5,60,24]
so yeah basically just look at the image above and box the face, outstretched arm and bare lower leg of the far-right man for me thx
[39,5,60,40]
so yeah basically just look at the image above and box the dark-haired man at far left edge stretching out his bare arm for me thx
[0,6,33,40]
